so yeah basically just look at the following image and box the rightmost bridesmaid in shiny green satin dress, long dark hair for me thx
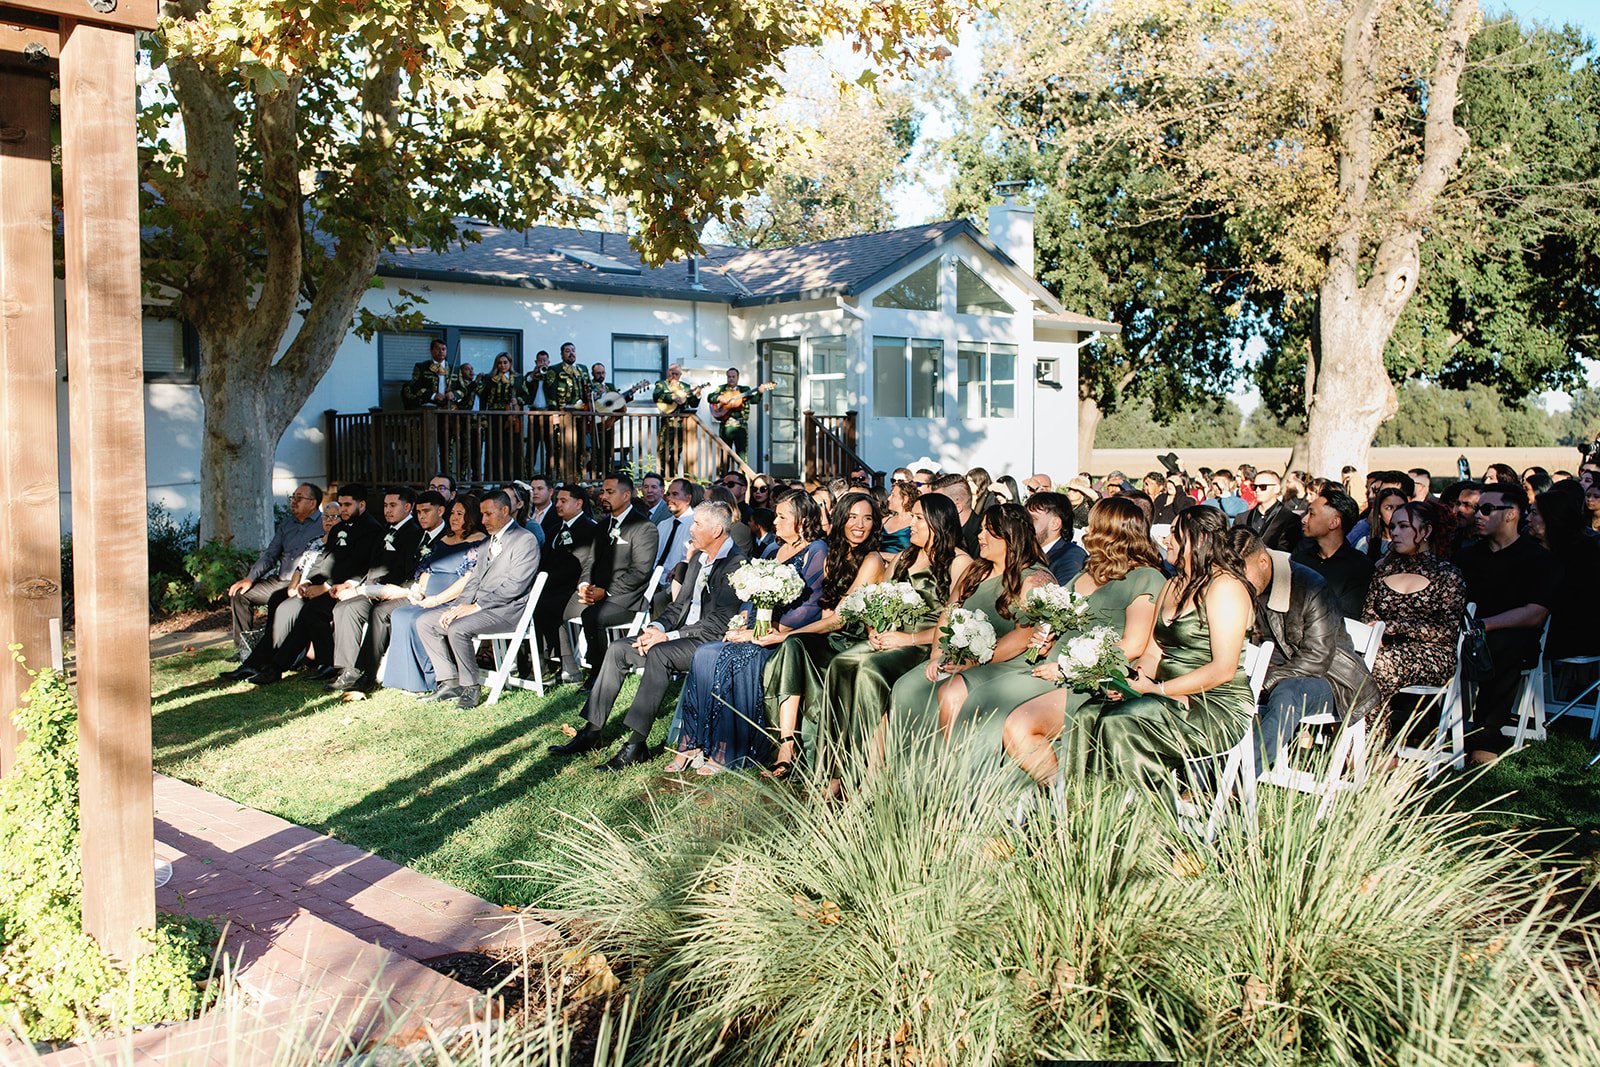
[1086,507,1256,789]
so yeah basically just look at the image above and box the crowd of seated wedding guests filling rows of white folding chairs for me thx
[224,464,1600,787]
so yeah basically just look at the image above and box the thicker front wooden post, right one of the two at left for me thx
[61,22,155,958]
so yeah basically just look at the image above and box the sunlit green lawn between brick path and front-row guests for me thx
[154,649,720,904]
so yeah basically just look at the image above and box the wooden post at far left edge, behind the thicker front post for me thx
[0,69,61,774]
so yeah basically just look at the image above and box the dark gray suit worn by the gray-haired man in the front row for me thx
[584,541,744,734]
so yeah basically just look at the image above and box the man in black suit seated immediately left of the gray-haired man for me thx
[562,474,656,685]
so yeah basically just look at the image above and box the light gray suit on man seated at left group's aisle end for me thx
[416,523,539,686]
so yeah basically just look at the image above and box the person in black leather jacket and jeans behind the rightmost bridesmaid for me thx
[1229,527,1378,769]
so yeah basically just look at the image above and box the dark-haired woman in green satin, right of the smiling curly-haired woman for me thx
[806,493,973,776]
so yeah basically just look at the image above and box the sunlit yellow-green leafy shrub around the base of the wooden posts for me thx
[0,659,214,1041]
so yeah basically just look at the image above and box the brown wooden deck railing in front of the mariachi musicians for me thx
[323,408,755,485]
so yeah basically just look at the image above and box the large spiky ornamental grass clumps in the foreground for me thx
[538,735,1600,1067]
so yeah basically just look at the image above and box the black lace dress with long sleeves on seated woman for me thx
[1362,552,1467,716]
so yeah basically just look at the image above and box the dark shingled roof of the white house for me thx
[378,219,1043,304]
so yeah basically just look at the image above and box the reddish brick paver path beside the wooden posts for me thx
[0,774,554,1067]
